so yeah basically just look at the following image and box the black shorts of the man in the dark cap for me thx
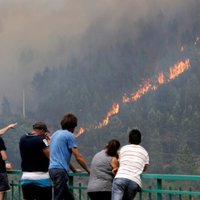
[22,185,52,200]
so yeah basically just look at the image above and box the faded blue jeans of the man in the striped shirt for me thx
[112,178,141,200]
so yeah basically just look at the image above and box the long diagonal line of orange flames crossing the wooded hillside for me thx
[75,59,191,137]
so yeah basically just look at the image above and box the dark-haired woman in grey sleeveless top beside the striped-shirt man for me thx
[87,139,120,200]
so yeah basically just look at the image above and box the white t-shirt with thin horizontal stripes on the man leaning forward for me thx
[115,144,149,187]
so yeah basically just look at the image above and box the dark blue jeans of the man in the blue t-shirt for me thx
[49,169,74,200]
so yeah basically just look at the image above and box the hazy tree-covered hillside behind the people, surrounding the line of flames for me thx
[0,2,200,174]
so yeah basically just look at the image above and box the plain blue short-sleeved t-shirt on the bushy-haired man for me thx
[49,130,77,173]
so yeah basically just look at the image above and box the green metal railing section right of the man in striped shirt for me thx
[139,174,200,200]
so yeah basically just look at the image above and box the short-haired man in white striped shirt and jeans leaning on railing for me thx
[112,129,149,200]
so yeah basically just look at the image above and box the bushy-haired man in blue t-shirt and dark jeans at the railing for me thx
[49,113,90,200]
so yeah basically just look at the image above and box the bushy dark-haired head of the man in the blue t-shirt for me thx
[60,113,78,133]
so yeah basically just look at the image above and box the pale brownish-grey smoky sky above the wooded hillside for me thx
[0,0,197,107]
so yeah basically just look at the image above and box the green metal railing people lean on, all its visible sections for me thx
[5,170,200,200]
